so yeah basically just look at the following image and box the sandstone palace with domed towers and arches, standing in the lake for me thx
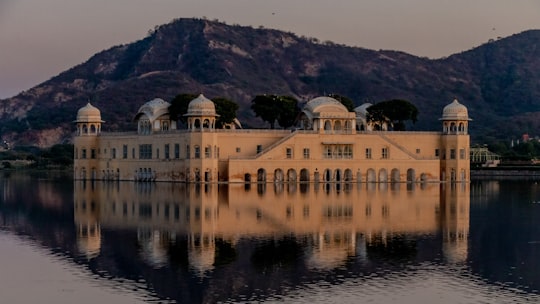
[74,95,470,183]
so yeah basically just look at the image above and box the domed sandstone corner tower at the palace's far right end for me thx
[440,99,471,182]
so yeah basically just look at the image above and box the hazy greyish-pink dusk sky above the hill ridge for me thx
[0,0,540,98]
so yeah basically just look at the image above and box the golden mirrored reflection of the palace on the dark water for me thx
[74,181,470,276]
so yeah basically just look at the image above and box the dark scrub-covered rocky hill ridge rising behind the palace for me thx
[0,19,540,146]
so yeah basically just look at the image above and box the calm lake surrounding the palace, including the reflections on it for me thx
[0,172,540,303]
